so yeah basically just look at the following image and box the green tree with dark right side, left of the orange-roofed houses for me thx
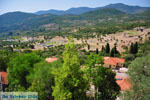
[85,54,120,100]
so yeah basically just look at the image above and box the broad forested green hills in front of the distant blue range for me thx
[0,5,150,37]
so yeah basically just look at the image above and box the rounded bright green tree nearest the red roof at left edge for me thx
[8,53,41,91]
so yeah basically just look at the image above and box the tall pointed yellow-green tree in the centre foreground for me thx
[52,39,87,100]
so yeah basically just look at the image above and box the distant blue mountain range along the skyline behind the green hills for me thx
[35,3,150,15]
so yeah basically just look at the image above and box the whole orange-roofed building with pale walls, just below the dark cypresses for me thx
[103,57,125,69]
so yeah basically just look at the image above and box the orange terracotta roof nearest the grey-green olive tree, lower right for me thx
[115,76,131,91]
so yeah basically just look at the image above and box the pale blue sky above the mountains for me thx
[0,0,150,14]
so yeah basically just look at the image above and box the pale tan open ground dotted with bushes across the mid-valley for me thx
[3,27,150,52]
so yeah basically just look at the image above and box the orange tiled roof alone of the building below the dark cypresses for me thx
[104,57,125,65]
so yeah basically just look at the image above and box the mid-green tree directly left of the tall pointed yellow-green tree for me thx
[27,60,62,100]
